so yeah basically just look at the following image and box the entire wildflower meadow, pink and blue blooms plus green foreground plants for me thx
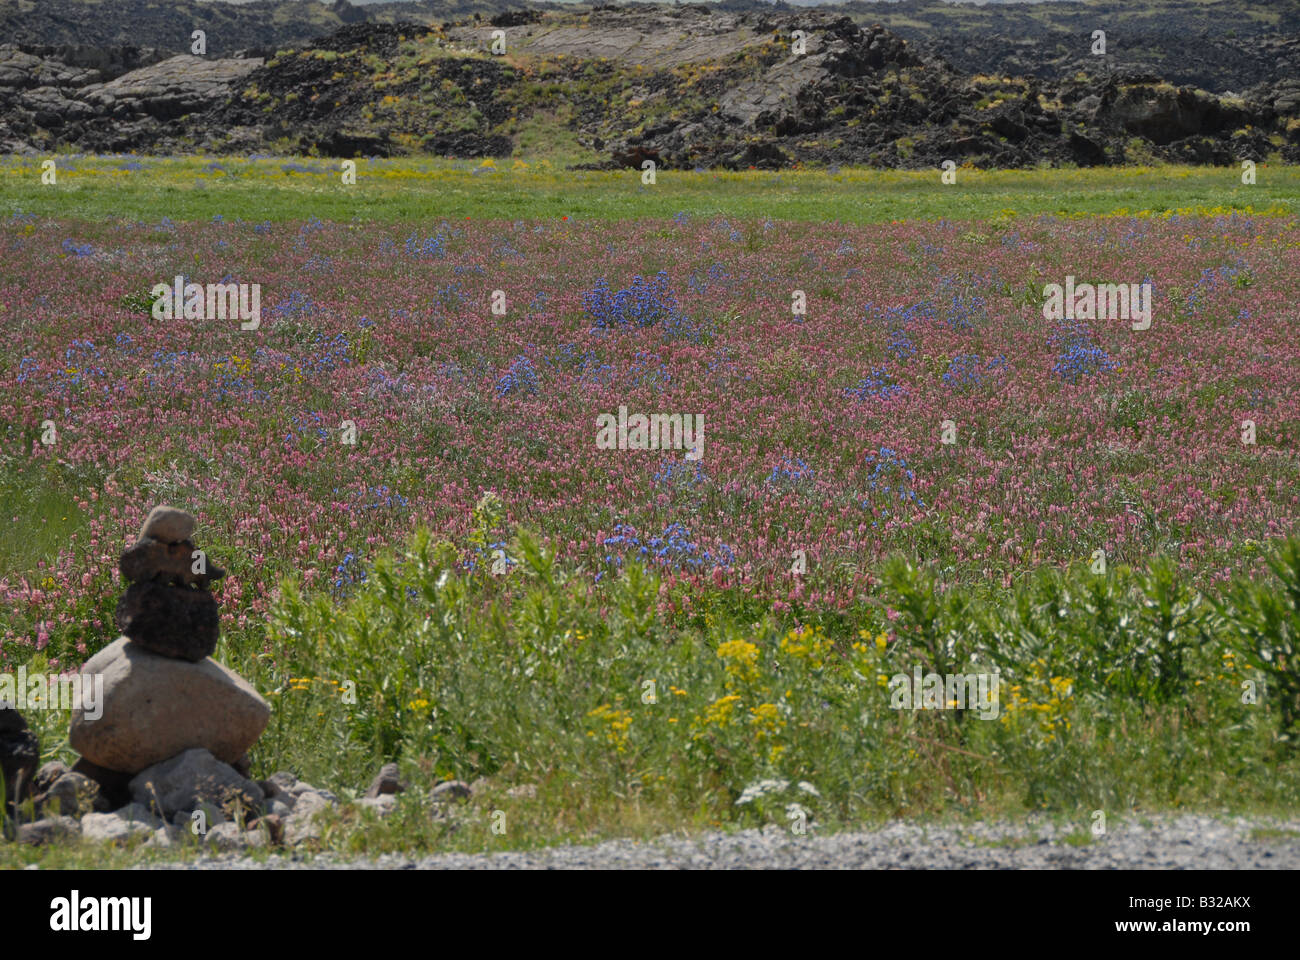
[0,158,1300,856]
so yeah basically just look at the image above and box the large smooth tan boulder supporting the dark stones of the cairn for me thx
[68,636,270,774]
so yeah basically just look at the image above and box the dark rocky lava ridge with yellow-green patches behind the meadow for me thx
[0,5,1300,168]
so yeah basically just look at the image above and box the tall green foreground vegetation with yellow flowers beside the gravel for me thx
[10,532,1300,866]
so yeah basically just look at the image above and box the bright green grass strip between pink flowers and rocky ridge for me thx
[0,156,1300,224]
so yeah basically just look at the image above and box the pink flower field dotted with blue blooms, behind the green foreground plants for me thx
[0,200,1300,842]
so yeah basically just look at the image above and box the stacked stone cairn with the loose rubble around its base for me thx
[8,506,472,851]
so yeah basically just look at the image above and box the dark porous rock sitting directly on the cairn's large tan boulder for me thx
[117,581,221,663]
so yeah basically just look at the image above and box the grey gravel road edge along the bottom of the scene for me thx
[142,816,1300,870]
